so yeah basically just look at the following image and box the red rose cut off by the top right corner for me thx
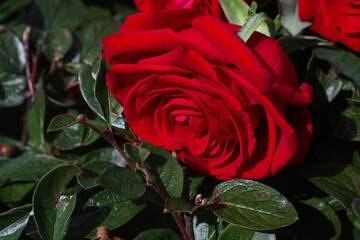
[298,0,360,52]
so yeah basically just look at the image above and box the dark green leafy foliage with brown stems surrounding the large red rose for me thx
[0,0,360,240]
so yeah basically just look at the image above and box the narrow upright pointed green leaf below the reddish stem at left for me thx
[27,81,45,152]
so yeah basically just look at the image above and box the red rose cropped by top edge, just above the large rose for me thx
[134,0,264,19]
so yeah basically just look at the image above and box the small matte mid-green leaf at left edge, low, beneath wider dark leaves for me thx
[0,182,35,206]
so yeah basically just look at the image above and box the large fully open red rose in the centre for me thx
[103,9,312,179]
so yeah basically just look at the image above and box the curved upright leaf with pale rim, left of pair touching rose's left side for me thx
[79,65,105,120]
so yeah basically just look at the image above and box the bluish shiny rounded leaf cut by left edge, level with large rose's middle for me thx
[0,71,26,108]
